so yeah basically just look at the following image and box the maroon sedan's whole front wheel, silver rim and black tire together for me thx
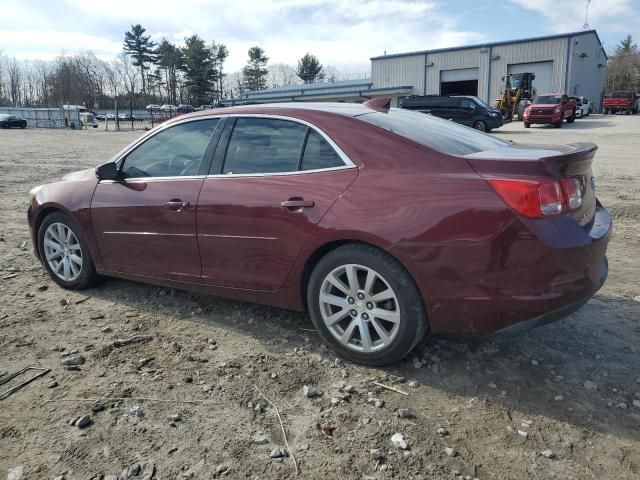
[38,212,98,290]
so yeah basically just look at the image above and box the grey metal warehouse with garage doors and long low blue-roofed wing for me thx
[223,30,607,108]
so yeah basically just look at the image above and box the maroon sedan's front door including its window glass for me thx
[91,118,221,282]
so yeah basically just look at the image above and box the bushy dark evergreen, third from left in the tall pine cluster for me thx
[181,35,217,105]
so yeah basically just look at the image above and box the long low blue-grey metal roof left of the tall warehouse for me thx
[222,78,413,105]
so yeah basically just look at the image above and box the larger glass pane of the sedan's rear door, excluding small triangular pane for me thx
[222,118,307,173]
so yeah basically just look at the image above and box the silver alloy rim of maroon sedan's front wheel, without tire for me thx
[43,223,83,282]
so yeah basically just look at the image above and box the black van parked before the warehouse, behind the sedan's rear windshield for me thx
[401,95,502,132]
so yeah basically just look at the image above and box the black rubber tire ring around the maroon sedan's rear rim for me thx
[307,244,427,366]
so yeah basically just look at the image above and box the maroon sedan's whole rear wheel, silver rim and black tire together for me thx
[307,244,426,365]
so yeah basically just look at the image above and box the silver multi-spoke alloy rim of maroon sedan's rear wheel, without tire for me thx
[318,264,401,353]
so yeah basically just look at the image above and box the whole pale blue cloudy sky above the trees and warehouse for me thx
[0,0,640,73]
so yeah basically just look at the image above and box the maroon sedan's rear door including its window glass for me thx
[198,116,358,291]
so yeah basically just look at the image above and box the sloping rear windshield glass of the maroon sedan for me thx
[356,108,508,155]
